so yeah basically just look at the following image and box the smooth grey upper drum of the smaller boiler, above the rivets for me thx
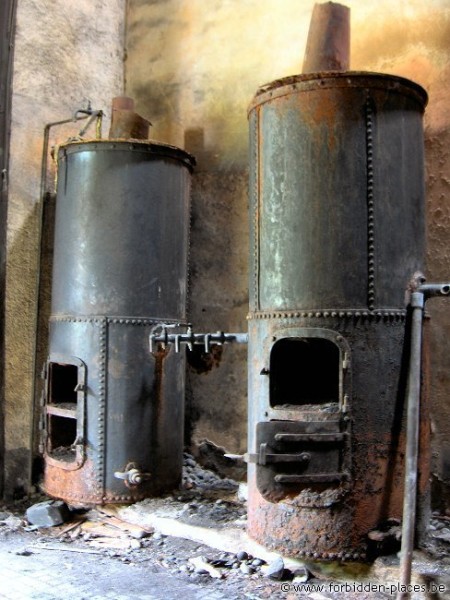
[52,141,192,321]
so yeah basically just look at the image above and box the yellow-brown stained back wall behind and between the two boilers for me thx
[125,0,450,502]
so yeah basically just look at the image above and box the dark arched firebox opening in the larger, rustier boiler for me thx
[270,338,340,408]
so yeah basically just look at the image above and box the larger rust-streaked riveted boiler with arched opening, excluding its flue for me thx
[248,71,427,561]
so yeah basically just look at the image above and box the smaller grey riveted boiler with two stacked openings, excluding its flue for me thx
[44,130,194,505]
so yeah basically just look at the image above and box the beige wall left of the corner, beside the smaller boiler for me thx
[4,0,126,494]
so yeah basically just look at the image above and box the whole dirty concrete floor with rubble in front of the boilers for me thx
[0,458,450,600]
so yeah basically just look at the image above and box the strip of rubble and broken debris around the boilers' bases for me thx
[0,453,450,600]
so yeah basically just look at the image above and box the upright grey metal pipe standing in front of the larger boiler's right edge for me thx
[397,292,425,600]
